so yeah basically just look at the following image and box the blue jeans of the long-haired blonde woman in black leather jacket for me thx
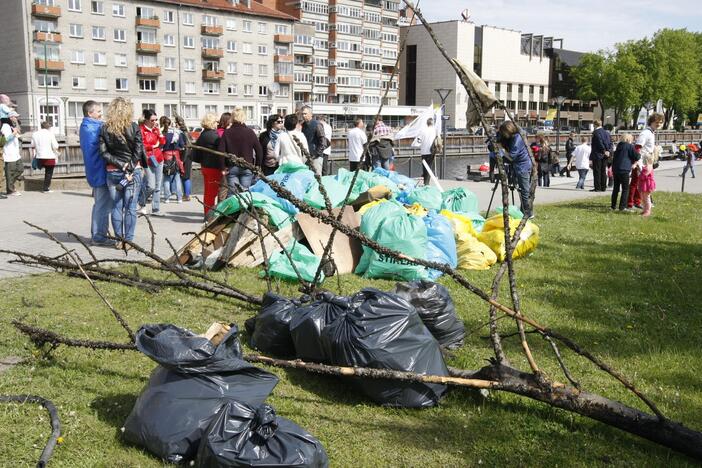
[107,168,144,241]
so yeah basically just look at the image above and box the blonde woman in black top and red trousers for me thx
[193,113,226,219]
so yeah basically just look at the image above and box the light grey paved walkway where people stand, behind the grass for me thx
[0,161,702,278]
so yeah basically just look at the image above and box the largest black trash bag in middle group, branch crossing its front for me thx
[321,288,449,408]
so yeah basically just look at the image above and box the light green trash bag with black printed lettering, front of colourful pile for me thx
[363,213,429,281]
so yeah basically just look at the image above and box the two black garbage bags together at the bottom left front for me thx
[122,325,328,467]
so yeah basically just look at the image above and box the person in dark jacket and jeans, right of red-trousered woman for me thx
[219,106,263,197]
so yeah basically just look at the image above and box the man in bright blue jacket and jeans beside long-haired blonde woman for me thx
[80,101,115,246]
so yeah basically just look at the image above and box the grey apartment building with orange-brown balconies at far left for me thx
[0,0,295,134]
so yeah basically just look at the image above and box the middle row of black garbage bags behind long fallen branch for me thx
[246,281,465,408]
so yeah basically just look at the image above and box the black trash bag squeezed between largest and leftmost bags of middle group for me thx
[290,292,350,362]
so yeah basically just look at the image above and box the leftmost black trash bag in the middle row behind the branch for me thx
[246,293,300,357]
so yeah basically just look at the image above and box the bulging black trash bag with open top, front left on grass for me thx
[123,325,278,463]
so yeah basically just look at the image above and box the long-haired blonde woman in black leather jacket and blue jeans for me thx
[100,97,146,249]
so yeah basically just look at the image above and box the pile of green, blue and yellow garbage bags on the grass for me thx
[216,163,539,281]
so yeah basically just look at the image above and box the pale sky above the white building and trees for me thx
[419,0,702,52]
